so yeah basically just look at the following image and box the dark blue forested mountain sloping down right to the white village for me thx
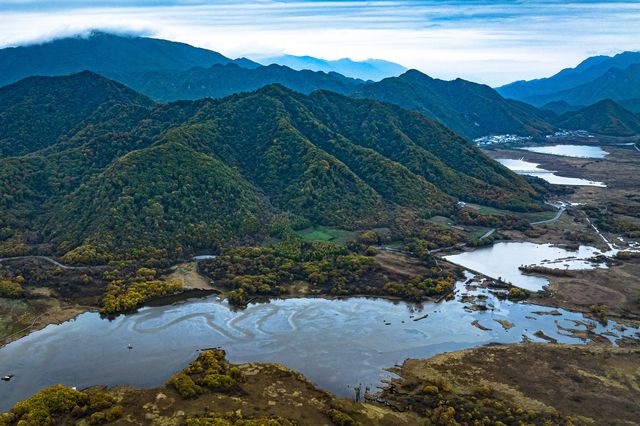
[352,70,553,138]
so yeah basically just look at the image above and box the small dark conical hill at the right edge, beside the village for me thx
[556,99,640,136]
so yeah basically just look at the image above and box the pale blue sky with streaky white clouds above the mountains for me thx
[0,0,640,86]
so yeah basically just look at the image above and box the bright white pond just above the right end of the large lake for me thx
[445,242,607,291]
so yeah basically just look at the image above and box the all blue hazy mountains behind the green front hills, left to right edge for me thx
[0,32,640,143]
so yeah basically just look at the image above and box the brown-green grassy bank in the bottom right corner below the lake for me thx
[383,343,640,425]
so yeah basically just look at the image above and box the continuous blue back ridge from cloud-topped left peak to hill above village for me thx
[0,33,552,138]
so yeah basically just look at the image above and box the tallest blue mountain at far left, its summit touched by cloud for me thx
[0,32,250,86]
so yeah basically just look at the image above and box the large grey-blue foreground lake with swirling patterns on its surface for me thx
[0,274,640,411]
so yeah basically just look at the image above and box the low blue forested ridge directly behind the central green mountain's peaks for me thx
[111,63,364,102]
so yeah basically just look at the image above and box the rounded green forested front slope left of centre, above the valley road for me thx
[51,141,270,256]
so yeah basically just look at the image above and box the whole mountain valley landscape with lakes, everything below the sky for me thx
[0,31,640,426]
